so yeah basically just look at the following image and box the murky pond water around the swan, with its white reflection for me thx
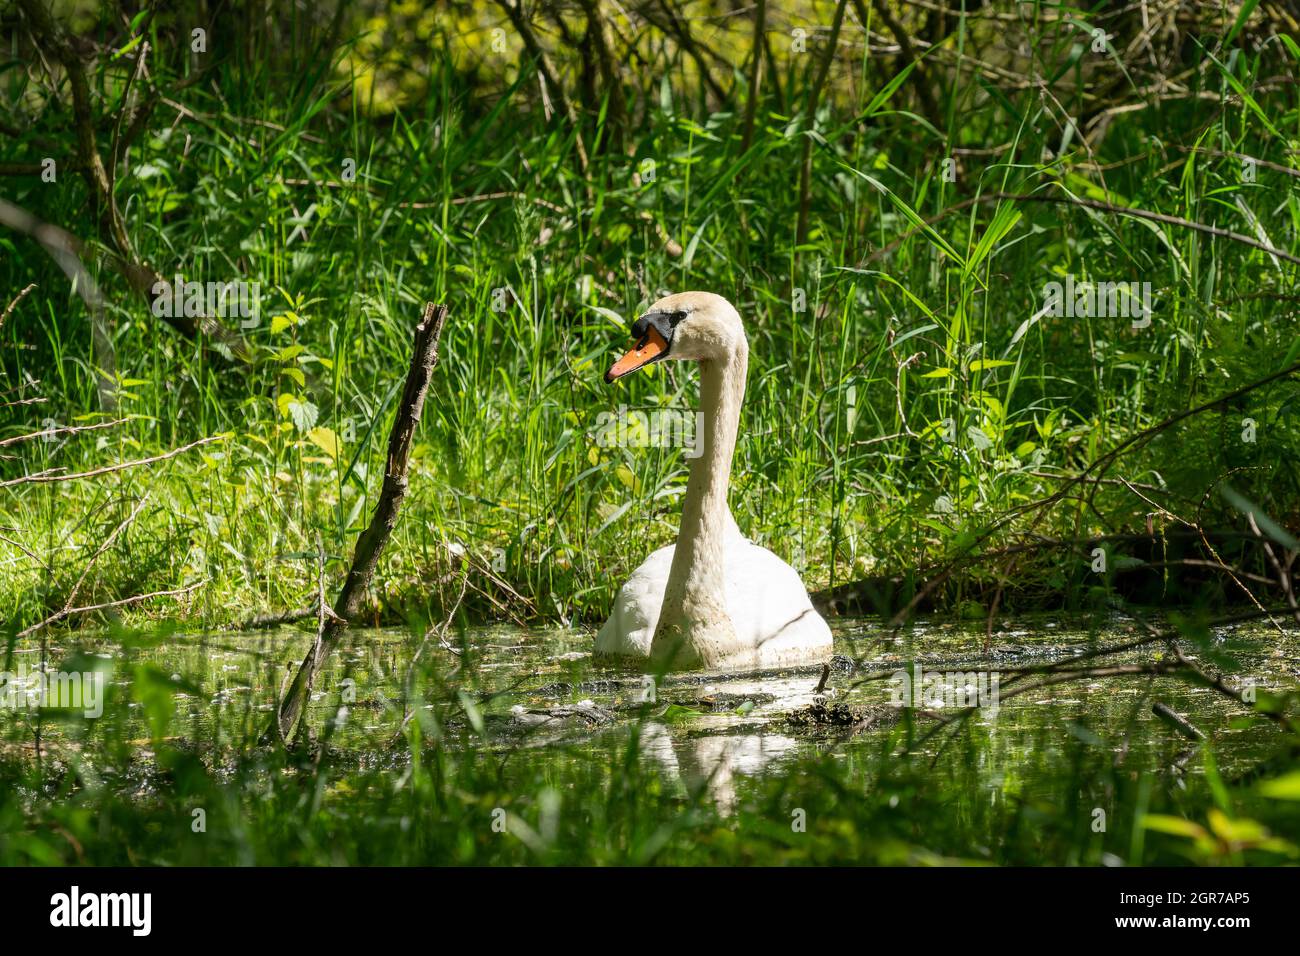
[15,617,1300,814]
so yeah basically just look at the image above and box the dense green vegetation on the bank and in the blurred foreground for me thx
[0,0,1300,864]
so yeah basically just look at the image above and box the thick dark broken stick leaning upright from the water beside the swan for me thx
[261,302,447,744]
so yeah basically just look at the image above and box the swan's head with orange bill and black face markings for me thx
[605,293,748,382]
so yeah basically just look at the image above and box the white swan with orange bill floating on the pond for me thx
[595,293,831,670]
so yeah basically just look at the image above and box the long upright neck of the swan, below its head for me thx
[650,338,749,667]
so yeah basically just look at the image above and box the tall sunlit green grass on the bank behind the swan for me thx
[0,4,1300,624]
